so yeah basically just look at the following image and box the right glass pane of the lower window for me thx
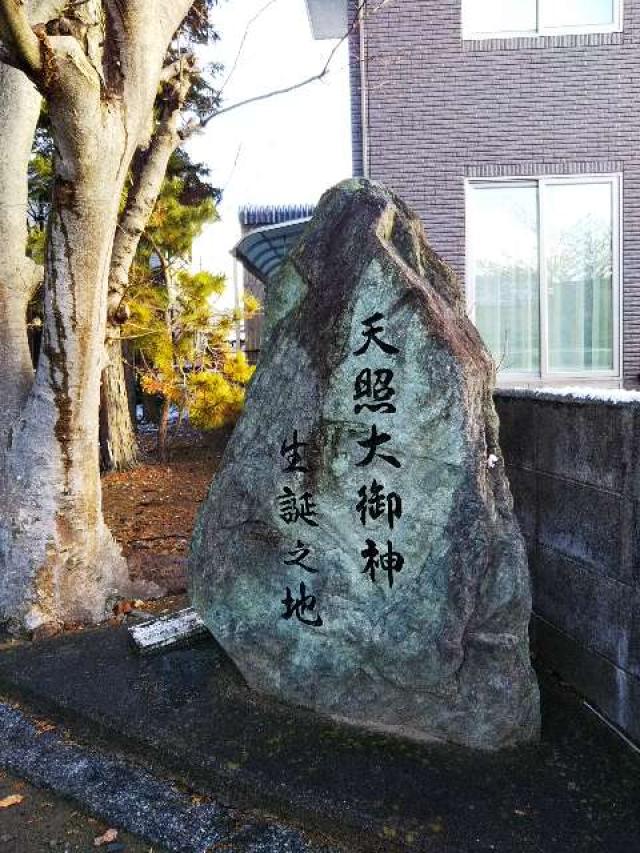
[543,183,614,373]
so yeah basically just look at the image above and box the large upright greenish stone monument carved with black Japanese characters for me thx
[190,180,539,749]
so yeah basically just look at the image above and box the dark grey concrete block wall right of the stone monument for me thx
[496,391,640,743]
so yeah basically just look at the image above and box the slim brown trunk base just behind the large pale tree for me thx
[100,335,138,471]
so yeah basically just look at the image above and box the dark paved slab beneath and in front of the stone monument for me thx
[0,627,640,853]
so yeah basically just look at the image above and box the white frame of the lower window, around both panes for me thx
[464,172,623,386]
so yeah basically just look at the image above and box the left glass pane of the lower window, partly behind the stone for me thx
[471,184,540,373]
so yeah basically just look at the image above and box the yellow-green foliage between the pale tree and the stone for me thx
[123,162,260,430]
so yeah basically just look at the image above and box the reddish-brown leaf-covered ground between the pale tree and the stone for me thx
[102,426,228,595]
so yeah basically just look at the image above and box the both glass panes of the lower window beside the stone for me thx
[469,178,617,375]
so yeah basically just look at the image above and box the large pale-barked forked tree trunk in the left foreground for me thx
[0,0,195,629]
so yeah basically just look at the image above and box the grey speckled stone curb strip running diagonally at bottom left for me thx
[0,703,338,853]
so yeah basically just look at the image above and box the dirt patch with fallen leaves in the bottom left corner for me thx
[0,770,163,853]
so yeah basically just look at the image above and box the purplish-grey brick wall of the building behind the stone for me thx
[350,0,640,387]
